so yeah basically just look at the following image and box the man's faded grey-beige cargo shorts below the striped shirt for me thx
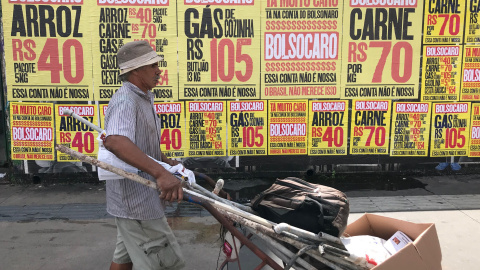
[113,217,185,270]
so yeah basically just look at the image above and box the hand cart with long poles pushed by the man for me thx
[55,111,368,270]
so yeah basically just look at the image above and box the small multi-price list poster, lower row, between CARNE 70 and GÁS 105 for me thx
[390,102,432,157]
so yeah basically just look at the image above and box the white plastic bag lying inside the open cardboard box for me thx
[341,235,391,268]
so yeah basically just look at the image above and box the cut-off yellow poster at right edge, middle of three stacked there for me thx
[460,45,480,101]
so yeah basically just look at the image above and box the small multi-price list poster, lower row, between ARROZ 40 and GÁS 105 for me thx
[186,101,227,157]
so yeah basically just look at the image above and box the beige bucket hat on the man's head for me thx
[117,40,163,75]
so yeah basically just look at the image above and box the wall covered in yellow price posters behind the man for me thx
[1,0,480,173]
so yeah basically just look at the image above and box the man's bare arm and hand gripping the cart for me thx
[104,135,183,202]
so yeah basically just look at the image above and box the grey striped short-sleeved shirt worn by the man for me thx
[105,82,164,220]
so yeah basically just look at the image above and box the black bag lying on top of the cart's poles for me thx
[252,177,350,237]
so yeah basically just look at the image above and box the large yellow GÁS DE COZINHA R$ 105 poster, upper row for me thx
[177,0,261,100]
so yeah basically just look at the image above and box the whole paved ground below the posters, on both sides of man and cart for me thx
[0,175,480,270]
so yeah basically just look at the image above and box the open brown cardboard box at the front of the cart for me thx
[344,214,442,270]
